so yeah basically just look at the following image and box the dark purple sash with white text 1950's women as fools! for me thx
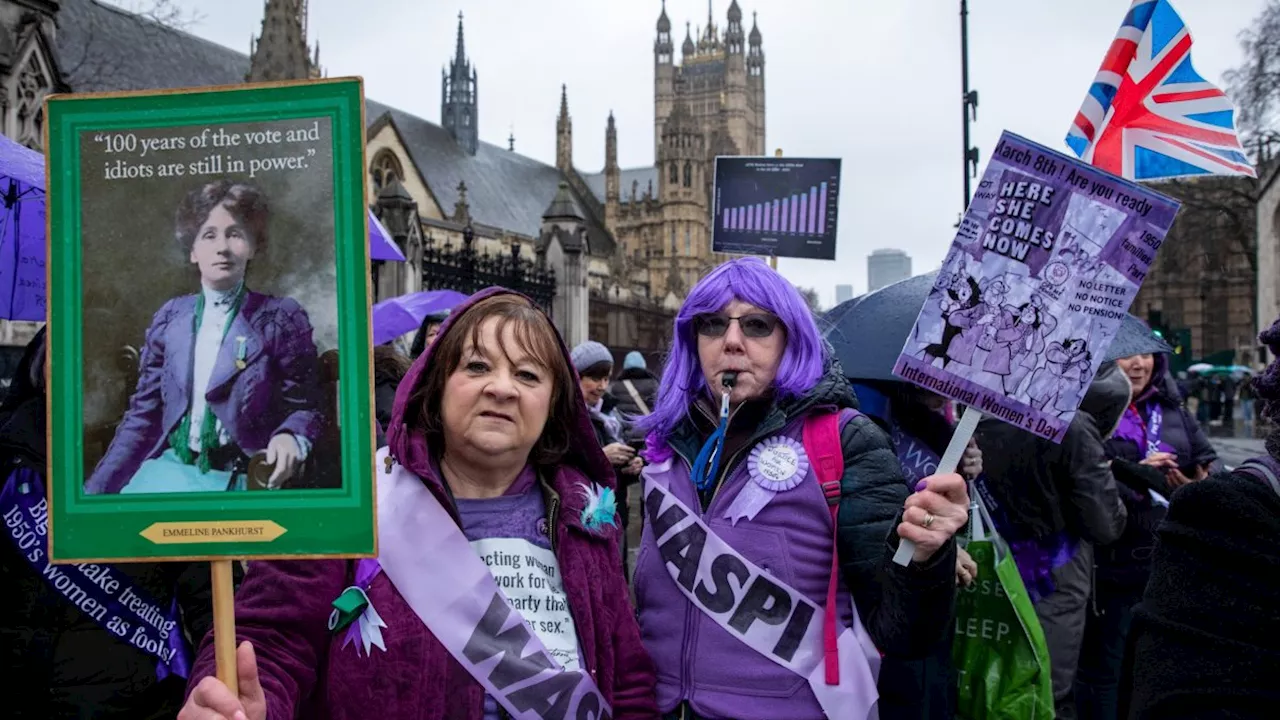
[0,468,191,680]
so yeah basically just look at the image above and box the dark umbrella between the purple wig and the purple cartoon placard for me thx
[824,272,938,382]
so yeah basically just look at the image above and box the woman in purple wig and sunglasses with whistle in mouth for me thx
[635,258,969,720]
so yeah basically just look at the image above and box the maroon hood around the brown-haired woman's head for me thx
[387,287,616,532]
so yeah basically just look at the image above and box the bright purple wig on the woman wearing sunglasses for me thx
[639,258,828,460]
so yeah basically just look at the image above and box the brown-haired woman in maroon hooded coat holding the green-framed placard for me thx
[179,288,658,720]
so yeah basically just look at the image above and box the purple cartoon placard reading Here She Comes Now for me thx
[893,132,1179,442]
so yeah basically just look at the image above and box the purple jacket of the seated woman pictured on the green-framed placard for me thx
[84,292,325,495]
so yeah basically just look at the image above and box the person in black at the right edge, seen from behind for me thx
[1120,316,1280,719]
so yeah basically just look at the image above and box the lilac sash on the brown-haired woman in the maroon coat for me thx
[378,448,613,720]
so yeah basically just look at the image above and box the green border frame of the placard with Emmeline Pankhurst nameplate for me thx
[45,78,378,562]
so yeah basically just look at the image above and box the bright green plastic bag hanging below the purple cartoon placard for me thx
[951,505,1053,720]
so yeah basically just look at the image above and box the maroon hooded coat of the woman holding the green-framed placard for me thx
[188,288,658,720]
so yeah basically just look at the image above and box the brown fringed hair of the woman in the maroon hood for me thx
[406,295,580,465]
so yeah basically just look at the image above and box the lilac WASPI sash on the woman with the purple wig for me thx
[644,460,881,720]
